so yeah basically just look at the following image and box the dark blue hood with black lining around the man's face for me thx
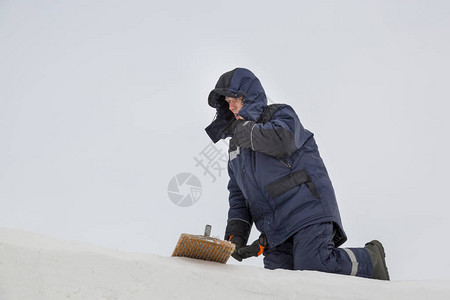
[206,68,267,142]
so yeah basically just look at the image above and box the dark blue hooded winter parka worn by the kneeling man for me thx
[206,68,347,247]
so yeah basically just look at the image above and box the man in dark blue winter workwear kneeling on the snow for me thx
[206,68,389,280]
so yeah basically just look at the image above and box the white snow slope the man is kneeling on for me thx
[0,229,450,300]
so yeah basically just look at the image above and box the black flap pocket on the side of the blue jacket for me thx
[266,170,320,199]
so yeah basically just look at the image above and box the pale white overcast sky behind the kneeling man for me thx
[0,0,450,280]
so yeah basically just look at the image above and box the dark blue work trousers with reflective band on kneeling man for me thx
[264,223,373,278]
